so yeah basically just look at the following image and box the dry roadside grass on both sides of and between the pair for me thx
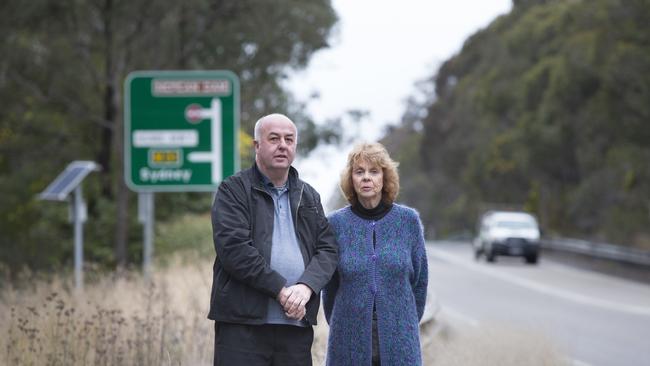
[0,260,568,366]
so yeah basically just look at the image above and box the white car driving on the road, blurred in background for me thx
[473,211,540,263]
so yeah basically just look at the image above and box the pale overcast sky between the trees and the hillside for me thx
[287,0,511,211]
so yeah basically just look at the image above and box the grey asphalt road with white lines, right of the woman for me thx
[427,242,650,366]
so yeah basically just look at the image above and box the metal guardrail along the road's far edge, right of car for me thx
[540,238,650,267]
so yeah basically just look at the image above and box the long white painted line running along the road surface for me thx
[427,246,650,316]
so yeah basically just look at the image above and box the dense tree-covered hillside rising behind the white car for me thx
[385,0,650,248]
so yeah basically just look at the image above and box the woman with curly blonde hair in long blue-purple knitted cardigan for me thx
[323,143,428,366]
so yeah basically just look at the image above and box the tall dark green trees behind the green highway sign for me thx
[0,0,337,268]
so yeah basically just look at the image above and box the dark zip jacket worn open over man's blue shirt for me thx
[208,165,338,325]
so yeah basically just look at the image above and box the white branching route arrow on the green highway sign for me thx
[187,98,222,183]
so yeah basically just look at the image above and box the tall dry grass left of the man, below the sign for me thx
[0,263,214,366]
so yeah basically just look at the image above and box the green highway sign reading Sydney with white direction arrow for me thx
[124,71,239,192]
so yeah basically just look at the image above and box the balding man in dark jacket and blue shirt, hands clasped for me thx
[208,114,338,366]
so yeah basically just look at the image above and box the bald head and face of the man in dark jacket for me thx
[255,117,297,171]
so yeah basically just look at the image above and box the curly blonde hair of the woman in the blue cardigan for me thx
[339,142,399,205]
